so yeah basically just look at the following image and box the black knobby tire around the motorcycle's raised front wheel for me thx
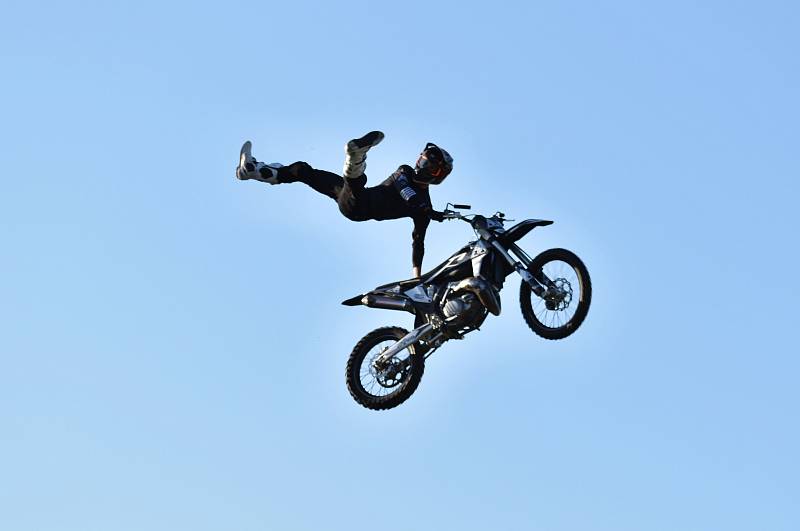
[519,249,592,339]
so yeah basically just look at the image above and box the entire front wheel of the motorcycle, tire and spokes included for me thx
[519,249,592,339]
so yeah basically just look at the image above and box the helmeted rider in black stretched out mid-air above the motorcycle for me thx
[236,131,453,277]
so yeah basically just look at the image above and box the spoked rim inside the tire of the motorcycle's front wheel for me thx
[531,260,583,329]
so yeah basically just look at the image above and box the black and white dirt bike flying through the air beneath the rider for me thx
[342,203,592,410]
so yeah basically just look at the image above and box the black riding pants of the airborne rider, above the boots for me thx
[278,162,369,221]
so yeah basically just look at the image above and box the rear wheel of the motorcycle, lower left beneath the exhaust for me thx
[346,326,425,410]
